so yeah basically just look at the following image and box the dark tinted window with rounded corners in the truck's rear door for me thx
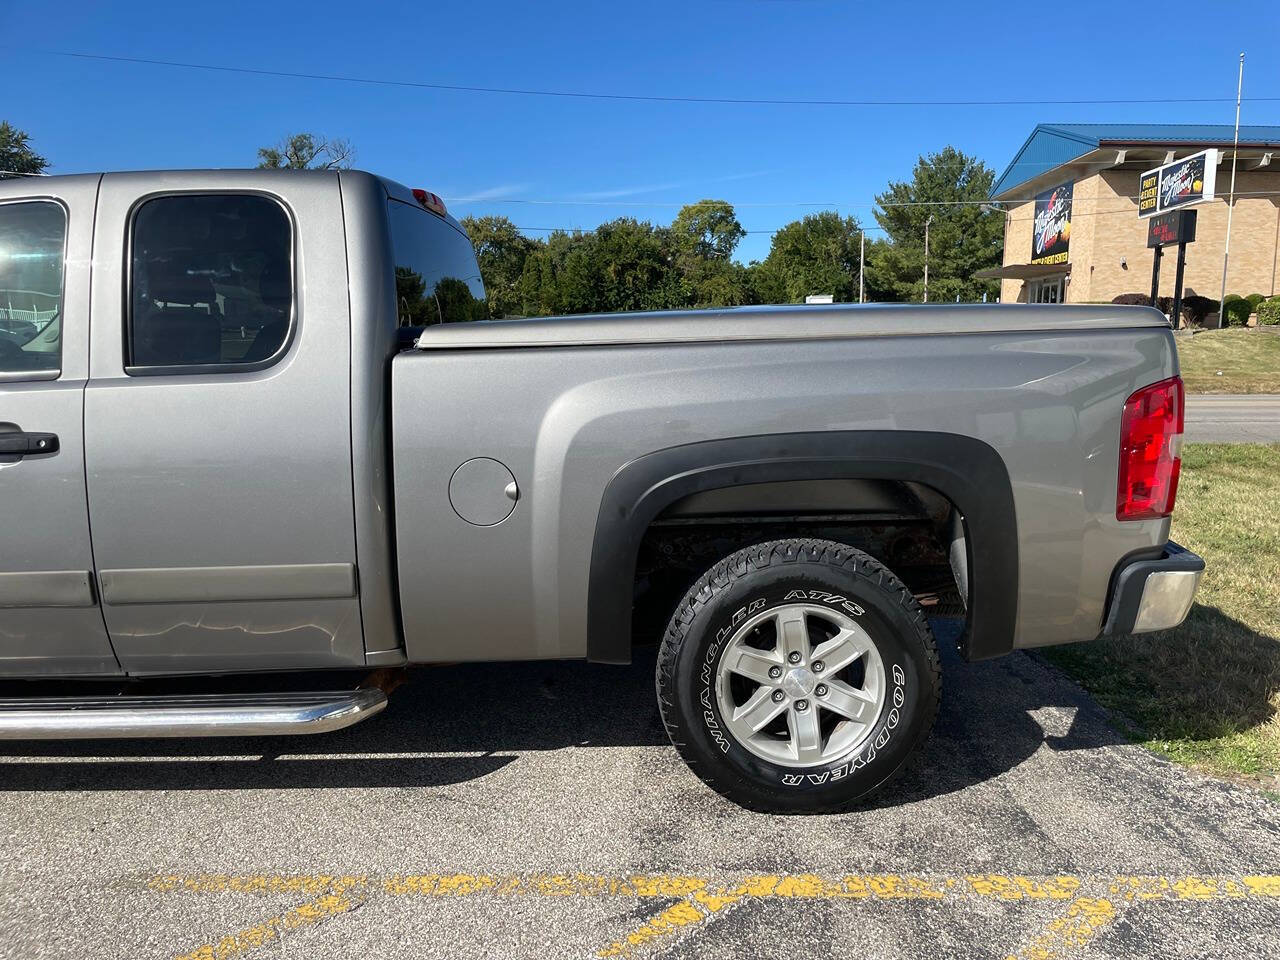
[128,195,293,367]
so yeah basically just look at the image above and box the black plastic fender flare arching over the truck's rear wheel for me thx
[586,430,1018,663]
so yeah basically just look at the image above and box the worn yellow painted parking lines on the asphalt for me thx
[157,873,1280,960]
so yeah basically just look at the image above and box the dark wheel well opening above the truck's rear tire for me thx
[631,479,968,643]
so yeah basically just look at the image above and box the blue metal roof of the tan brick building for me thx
[989,123,1280,197]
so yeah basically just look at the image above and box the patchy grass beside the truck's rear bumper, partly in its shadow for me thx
[1043,442,1280,792]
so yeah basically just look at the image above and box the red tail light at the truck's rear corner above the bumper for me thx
[1116,376,1184,520]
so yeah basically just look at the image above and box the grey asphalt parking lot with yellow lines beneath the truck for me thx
[0,625,1280,960]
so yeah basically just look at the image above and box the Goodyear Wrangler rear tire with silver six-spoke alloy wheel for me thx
[657,540,942,813]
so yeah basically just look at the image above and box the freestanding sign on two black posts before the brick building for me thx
[1138,150,1221,328]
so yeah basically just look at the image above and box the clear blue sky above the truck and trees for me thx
[0,0,1280,260]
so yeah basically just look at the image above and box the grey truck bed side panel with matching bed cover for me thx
[392,316,1176,660]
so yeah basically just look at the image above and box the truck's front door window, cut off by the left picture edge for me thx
[0,200,67,376]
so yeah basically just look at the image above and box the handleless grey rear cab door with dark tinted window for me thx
[84,172,364,673]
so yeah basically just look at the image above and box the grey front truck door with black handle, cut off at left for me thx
[0,175,120,676]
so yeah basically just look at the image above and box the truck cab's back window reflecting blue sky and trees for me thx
[389,200,489,326]
